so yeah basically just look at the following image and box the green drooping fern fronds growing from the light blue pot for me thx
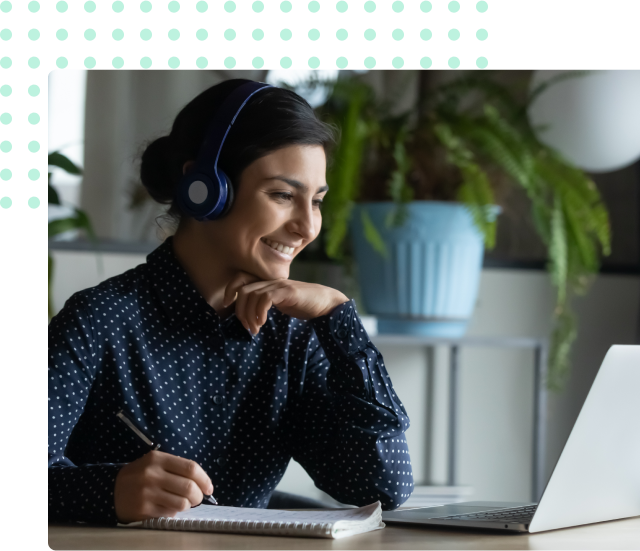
[318,71,611,389]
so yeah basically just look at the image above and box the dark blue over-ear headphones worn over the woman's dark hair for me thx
[176,82,272,222]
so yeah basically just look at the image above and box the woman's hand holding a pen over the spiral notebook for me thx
[114,451,213,524]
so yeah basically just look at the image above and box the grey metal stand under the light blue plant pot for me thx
[371,333,549,502]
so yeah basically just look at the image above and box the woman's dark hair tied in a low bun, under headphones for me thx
[140,79,336,232]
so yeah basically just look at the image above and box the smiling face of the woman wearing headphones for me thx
[201,145,328,280]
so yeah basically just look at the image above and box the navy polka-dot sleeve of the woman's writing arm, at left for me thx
[48,293,122,525]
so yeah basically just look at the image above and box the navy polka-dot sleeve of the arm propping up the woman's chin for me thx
[284,300,413,510]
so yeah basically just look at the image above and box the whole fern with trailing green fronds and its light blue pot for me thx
[308,71,610,389]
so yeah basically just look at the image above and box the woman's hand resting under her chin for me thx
[224,272,349,335]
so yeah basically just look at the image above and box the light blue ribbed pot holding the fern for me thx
[350,201,500,338]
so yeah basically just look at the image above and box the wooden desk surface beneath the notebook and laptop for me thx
[49,517,640,551]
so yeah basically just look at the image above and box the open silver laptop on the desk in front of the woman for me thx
[382,345,640,533]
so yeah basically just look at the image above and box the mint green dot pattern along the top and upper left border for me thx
[0,0,489,217]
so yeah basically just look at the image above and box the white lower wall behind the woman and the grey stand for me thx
[47,250,640,508]
